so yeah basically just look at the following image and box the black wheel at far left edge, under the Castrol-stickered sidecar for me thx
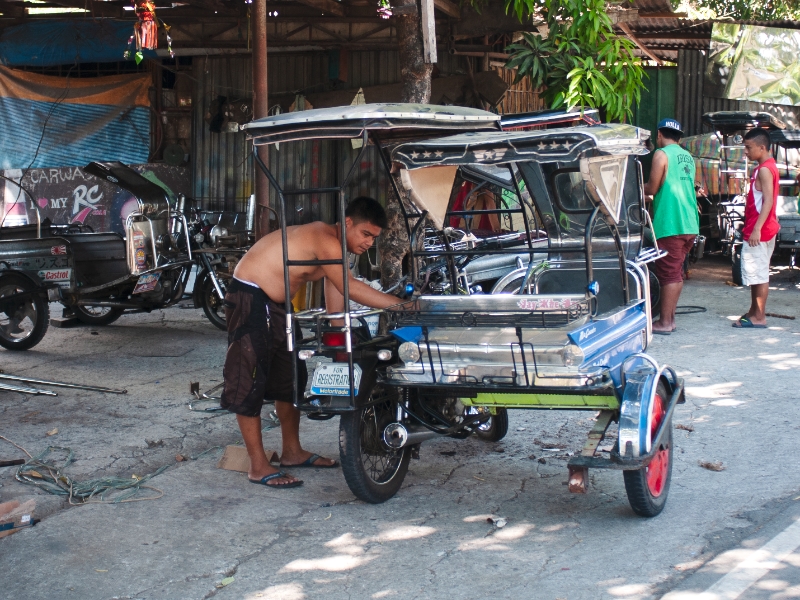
[0,273,50,351]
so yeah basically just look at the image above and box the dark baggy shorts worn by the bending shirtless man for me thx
[221,279,308,417]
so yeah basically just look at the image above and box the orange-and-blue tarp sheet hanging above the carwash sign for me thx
[0,66,151,169]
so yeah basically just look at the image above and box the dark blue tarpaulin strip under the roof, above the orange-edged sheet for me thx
[0,19,156,67]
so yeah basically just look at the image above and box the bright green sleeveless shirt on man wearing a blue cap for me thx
[653,144,700,239]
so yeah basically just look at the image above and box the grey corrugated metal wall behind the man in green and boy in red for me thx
[676,50,800,135]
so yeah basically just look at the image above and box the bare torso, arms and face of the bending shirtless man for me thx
[234,217,400,308]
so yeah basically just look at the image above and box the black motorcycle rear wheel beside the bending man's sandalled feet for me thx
[339,382,411,504]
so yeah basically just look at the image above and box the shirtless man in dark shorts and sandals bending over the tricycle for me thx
[221,197,400,488]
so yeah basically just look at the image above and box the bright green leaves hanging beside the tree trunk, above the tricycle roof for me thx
[504,0,645,121]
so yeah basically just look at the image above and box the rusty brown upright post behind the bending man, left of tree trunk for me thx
[250,0,269,240]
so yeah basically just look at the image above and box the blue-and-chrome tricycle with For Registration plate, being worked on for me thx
[244,104,683,516]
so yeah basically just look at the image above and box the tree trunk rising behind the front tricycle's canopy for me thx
[378,0,433,288]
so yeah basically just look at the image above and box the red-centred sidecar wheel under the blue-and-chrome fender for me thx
[622,381,672,517]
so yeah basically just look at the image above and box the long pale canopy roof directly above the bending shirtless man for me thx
[242,103,500,146]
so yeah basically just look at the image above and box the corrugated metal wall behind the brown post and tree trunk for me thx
[192,50,542,217]
